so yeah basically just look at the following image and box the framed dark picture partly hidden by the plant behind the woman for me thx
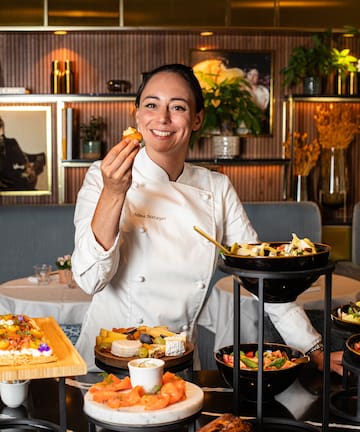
[190,49,273,135]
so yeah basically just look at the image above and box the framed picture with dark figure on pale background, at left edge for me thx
[0,105,52,196]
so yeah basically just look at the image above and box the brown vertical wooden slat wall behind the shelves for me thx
[0,31,360,219]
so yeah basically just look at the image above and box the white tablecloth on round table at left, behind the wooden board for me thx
[0,275,91,324]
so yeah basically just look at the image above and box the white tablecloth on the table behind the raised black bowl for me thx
[198,274,360,350]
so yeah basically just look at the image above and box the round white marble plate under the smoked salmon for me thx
[84,382,204,426]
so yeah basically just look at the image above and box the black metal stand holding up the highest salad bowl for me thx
[220,263,334,432]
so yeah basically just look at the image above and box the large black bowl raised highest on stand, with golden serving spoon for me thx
[221,242,330,303]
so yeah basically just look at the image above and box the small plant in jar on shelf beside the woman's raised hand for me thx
[80,116,105,160]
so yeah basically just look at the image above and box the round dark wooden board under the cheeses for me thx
[95,342,194,370]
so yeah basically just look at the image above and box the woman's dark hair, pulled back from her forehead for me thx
[135,63,204,113]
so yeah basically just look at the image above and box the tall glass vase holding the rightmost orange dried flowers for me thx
[320,147,349,207]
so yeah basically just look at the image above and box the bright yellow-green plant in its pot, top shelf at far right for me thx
[331,48,358,96]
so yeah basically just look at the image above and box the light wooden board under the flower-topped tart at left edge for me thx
[0,317,87,381]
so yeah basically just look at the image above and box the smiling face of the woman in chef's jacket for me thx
[136,72,203,162]
